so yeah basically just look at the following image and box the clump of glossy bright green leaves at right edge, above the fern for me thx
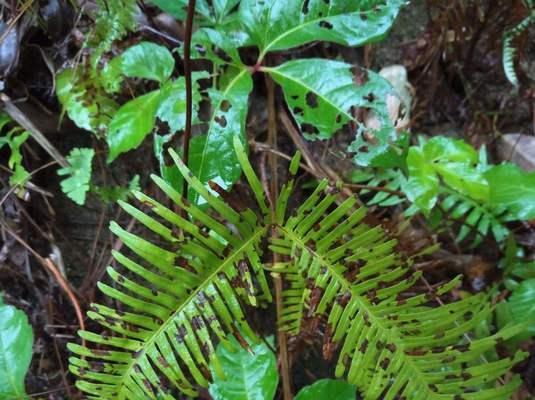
[352,136,535,246]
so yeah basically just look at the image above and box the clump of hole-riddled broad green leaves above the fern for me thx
[57,0,403,205]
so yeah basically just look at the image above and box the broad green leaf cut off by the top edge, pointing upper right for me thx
[239,0,404,57]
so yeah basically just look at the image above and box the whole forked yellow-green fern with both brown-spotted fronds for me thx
[69,138,523,399]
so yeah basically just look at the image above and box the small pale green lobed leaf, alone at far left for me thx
[58,148,95,205]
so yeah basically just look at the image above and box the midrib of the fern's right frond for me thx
[278,226,437,399]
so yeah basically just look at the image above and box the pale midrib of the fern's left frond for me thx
[118,226,268,399]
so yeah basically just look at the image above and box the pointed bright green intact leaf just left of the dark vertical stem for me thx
[106,90,161,162]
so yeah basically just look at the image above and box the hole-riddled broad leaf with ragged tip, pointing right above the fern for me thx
[264,59,396,166]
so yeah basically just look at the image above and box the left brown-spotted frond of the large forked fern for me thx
[69,143,271,400]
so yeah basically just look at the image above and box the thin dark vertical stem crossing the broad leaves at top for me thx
[182,0,195,199]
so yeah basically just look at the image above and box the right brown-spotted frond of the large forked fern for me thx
[271,182,523,400]
